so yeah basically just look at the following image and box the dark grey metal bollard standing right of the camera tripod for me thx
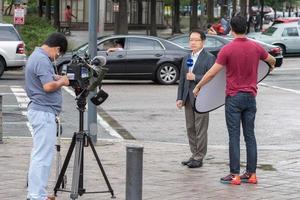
[126,145,144,200]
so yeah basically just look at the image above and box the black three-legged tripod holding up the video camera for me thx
[54,91,115,200]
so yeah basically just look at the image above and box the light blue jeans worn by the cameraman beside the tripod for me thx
[27,110,57,200]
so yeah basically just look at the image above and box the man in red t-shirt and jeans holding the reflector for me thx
[193,16,276,185]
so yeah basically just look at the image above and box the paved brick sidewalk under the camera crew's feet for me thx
[0,138,300,200]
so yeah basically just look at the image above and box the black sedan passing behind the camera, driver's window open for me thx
[57,35,190,85]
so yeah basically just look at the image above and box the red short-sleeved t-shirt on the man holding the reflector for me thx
[216,38,268,96]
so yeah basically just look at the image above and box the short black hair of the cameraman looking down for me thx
[43,33,68,54]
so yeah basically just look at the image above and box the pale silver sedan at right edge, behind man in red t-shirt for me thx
[248,22,300,55]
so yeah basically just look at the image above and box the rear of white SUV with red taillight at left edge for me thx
[0,23,27,77]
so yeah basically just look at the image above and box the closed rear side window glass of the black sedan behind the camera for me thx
[128,38,163,50]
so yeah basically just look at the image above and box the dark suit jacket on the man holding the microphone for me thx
[177,49,216,106]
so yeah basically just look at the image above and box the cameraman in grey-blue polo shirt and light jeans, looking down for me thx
[25,33,69,200]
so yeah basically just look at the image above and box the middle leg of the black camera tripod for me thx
[70,133,84,200]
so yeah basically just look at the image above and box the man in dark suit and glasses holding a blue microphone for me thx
[176,30,215,168]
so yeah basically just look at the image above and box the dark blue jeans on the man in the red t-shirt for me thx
[225,92,257,174]
